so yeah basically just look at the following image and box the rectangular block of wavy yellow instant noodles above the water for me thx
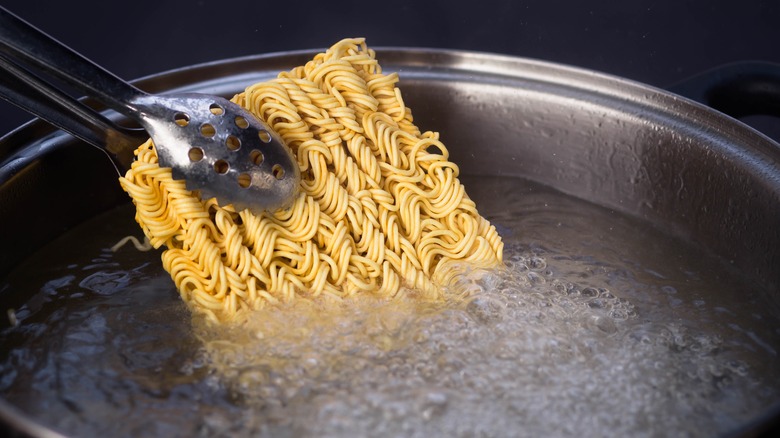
[120,39,503,321]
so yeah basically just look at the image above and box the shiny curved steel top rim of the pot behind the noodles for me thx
[0,46,780,154]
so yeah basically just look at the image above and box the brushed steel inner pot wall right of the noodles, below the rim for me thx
[406,76,780,298]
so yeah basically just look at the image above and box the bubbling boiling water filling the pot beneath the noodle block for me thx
[0,178,780,437]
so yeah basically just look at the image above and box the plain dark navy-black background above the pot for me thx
[0,0,780,135]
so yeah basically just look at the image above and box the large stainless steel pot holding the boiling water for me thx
[0,48,780,433]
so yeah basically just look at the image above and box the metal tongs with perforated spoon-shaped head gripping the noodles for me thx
[0,7,300,213]
